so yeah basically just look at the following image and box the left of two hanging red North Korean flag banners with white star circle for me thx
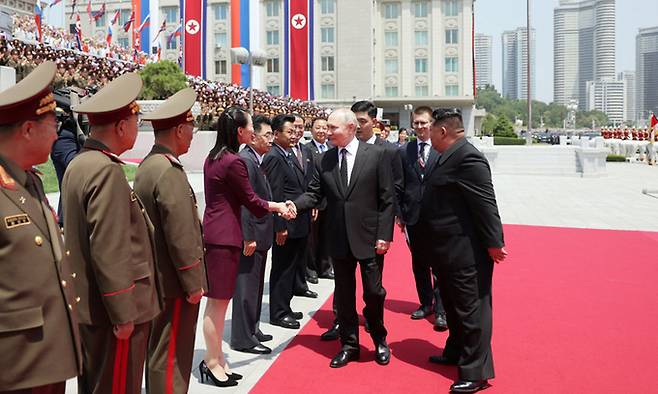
[180,0,207,78]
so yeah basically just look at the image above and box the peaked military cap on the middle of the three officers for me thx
[72,73,143,126]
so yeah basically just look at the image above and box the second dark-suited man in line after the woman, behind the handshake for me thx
[262,115,311,329]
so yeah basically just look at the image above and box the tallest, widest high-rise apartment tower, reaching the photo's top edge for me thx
[553,0,615,108]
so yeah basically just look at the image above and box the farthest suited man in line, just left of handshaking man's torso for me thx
[304,118,334,283]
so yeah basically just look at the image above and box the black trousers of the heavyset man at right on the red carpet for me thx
[437,262,494,380]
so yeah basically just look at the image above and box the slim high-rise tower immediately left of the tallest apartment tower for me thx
[502,27,536,100]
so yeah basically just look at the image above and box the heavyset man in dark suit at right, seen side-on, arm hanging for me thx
[412,109,507,393]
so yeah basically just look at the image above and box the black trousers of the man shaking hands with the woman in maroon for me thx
[333,256,387,350]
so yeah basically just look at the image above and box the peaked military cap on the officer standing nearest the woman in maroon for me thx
[142,88,196,130]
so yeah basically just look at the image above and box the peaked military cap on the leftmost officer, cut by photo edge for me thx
[0,62,57,125]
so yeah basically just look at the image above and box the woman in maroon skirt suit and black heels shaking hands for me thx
[199,107,294,387]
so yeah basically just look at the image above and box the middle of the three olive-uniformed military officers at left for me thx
[62,73,161,394]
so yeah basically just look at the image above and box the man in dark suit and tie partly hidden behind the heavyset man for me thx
[398,107,448,331]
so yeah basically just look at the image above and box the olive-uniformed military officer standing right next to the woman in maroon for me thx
[135,88,208,394]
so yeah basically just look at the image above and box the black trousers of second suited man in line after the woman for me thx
[270,237,308,320]
